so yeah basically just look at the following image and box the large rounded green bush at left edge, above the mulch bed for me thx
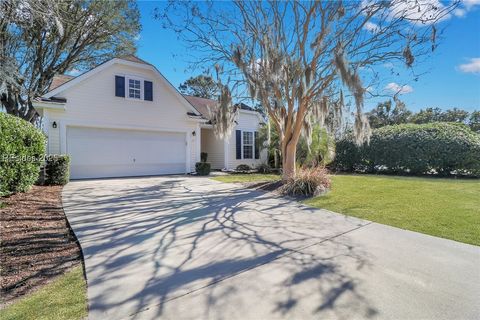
[0,112,45,196]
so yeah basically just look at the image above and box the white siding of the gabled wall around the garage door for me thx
[45,64,200,175]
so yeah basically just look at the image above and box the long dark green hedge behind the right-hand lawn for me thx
[333,123,480,176]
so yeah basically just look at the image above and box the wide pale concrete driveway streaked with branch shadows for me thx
[63,176,480,320]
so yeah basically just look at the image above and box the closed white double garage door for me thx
[66,127,186,179]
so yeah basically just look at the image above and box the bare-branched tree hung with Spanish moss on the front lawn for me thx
[157,0,457,179]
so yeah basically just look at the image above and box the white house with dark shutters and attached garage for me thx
[34,56,266,179]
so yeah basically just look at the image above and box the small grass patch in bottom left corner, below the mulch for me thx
[0,266,87,320]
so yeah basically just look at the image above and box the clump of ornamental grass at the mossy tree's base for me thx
[280,167,331,197]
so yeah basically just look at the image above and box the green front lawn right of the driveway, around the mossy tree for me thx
[214,175,480,245]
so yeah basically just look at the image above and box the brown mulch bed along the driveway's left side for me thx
[0,186,81,305]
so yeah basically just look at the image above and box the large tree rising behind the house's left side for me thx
[0,0,141,122]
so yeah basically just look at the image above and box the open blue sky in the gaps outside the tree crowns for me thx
[137,0,480,111]
